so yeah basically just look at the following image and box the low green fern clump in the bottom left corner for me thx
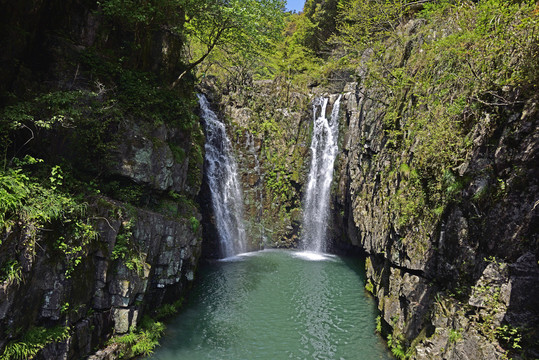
[0,326,70,360]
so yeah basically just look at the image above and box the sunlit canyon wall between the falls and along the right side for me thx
[206,16,539,359]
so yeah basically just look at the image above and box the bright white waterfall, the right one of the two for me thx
[302,95,341,252]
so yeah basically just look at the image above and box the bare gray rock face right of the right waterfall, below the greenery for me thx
[334,75,539,359]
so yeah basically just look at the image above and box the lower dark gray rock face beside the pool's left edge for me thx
[0,198,201,359]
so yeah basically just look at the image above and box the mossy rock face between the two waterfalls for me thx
[202,79,312,252]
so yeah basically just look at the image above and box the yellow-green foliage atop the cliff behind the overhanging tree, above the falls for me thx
[199,1,335,89]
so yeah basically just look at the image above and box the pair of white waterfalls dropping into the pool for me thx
[198,95,341,257]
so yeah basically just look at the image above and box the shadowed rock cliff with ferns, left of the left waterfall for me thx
[0,0,203,359]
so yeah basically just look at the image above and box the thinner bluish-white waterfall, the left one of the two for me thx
[197,94,246,257]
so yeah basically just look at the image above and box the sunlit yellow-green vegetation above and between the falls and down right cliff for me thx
[206,0,539,249]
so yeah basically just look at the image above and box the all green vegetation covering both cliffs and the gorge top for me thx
[0,0,539,359]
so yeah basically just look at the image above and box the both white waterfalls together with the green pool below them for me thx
[151,95,390,359]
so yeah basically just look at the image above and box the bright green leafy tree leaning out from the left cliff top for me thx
[100,0,284,88]
